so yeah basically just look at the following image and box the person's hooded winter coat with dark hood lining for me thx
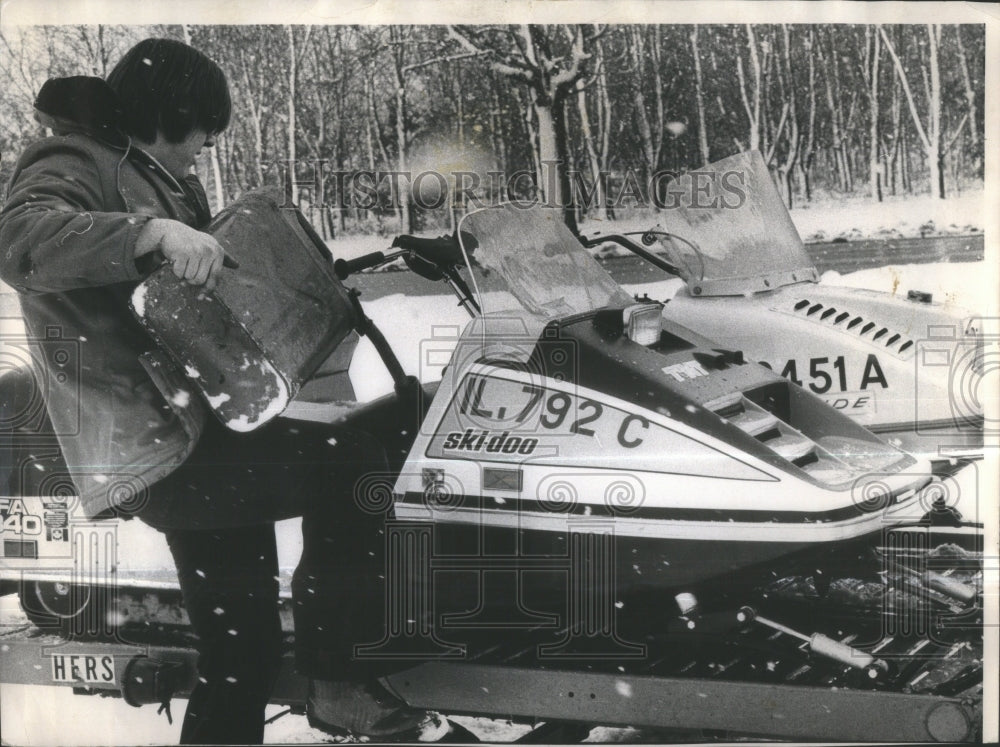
[0,78,209,517]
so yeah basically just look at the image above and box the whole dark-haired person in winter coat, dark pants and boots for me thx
[0,39,471,744]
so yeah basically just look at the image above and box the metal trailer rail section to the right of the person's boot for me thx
[387,662,980,742]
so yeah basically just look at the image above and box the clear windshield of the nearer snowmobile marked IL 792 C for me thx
[459,204,633,320]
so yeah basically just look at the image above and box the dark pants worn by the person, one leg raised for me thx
[139,420,388,744]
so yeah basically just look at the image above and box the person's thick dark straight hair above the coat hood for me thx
[108,39,232,143]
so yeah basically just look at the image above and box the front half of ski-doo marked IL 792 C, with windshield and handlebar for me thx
[330,199,968,591]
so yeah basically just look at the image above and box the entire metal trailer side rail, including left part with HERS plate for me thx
[0,639,982,742]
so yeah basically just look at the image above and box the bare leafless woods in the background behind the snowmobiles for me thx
[0,24,985,237]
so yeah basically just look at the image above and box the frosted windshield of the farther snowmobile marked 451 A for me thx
[652,151,819,296]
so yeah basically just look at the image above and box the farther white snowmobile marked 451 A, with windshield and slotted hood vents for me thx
[583,151,997,458]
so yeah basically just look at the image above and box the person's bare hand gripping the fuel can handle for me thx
[135,218,226,290]
